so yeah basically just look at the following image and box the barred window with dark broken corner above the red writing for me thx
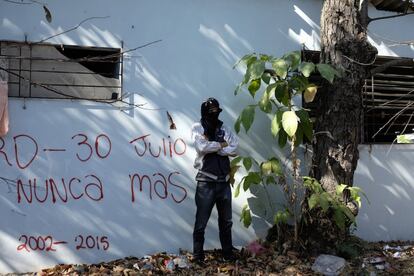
[0,41,122,100]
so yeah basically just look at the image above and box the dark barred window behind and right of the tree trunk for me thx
[302,50,414,144]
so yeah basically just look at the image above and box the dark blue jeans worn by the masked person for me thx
[193,181,233,259]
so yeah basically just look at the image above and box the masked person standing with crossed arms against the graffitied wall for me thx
[191,98,239,263]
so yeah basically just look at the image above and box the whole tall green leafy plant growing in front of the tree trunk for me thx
[231,51,368,245]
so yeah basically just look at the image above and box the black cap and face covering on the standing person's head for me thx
[200,98,223,142]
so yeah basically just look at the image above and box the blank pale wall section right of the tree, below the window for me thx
[354,144,414,241]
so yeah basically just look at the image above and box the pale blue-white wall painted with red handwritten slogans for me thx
[0,0,413,273]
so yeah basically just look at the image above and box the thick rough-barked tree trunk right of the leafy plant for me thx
[310,0,377,196]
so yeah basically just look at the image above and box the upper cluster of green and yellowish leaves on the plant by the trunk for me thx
[234,51,340,148]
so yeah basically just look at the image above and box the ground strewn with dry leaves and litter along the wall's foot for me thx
[10,241,414,276]
